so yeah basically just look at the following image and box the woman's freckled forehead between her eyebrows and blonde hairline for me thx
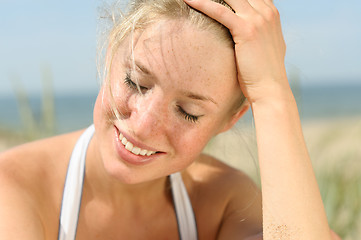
[134,21,236,90]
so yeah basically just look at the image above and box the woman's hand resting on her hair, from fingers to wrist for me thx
[186,0,288,103]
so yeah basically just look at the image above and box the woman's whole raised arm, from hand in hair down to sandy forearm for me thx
[185,0,337,240]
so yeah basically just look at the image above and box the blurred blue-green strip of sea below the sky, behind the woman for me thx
[0,84,361,133]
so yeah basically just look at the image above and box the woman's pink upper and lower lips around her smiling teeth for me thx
[114,126,165,165]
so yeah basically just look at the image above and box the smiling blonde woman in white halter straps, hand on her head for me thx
[0,0,337,240]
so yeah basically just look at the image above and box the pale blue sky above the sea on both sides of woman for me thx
[0,0,361,95]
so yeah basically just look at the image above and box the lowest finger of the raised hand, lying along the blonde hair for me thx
[184,0,243,31]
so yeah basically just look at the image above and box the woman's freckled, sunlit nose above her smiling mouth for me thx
[128,94,167,140]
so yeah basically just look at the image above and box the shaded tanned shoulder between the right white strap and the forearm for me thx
[187,155,262,239]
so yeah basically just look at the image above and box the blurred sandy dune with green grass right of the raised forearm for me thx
[305,117,361,240]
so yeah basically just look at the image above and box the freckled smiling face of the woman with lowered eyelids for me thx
[94,21,241,183]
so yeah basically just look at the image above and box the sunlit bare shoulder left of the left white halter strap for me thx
[0,132,80,239]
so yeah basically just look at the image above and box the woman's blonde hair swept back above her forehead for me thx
[100,0,245,117]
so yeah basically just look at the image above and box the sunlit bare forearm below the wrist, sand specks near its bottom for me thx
[251,83,330,240]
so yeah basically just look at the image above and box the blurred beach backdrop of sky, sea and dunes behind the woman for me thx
[0,0,361,239]
